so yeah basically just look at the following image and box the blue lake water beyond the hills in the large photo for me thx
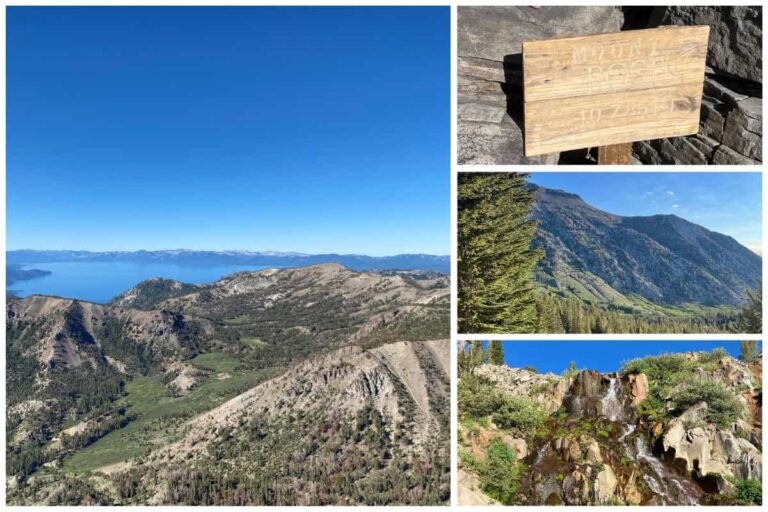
[8,262,265,303]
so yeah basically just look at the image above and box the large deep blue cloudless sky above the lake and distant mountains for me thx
[7,7,450,255]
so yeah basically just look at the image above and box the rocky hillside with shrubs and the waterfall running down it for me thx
[459,350,762,505]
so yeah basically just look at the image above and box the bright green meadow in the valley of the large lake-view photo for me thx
[64,366,278,473]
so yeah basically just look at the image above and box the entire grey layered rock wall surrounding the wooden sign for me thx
[457,6,762,165]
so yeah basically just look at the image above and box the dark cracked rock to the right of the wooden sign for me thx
[625,5,763,165]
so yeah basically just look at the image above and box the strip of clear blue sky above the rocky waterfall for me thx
[502,340,762,374]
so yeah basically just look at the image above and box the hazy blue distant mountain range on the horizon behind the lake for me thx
[6,249,451,273]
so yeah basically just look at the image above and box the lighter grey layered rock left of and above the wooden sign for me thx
[458,6,623,164]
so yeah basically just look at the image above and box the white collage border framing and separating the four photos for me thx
[0,0,768,512]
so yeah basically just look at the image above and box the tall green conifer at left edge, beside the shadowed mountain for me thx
[458,173,541,334]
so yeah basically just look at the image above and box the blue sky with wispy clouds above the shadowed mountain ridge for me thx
[531,171,762,250]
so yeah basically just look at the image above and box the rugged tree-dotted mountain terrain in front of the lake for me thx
[6,264,449,504]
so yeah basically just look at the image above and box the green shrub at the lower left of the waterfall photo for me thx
[479,439,525,505]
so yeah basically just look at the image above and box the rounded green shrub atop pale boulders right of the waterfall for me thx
[670,380,744,428]
